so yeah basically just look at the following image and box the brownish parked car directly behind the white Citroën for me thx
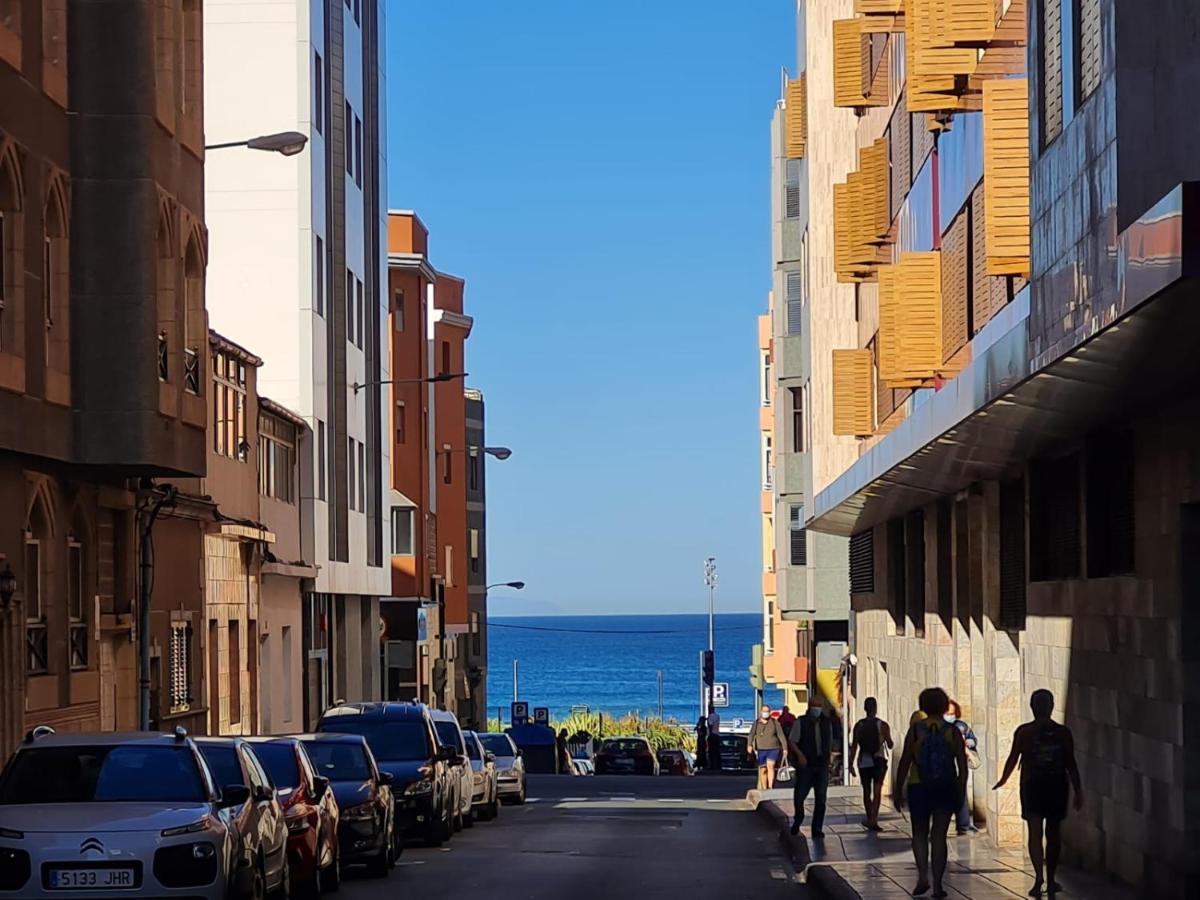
[196,738,292,900]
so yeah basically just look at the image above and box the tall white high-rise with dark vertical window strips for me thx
[204,0,391,725]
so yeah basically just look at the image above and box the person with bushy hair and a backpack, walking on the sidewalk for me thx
[892,688,967,898]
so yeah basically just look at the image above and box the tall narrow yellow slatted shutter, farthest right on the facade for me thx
[983,78,1030,277]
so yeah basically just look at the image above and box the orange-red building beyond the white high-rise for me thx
[383,211,472,708]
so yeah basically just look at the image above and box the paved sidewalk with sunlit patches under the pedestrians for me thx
[750,786,1136,900]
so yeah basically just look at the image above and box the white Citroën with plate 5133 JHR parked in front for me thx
[0,728,238,900]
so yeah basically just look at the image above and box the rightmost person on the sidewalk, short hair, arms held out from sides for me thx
[994,689,1084,896]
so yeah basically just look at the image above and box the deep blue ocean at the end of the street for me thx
[487,613,782,724]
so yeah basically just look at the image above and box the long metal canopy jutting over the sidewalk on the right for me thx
[808,185,1200,535]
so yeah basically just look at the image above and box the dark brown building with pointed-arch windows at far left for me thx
[0,0,208,756]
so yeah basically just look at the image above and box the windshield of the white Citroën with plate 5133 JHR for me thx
[0,744,208,804]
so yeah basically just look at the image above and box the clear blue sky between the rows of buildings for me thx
[386,0,794,616]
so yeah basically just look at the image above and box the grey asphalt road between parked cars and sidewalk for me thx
[341,775,809,900]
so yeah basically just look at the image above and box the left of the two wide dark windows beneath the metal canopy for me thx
[1030,454,1082,581]
